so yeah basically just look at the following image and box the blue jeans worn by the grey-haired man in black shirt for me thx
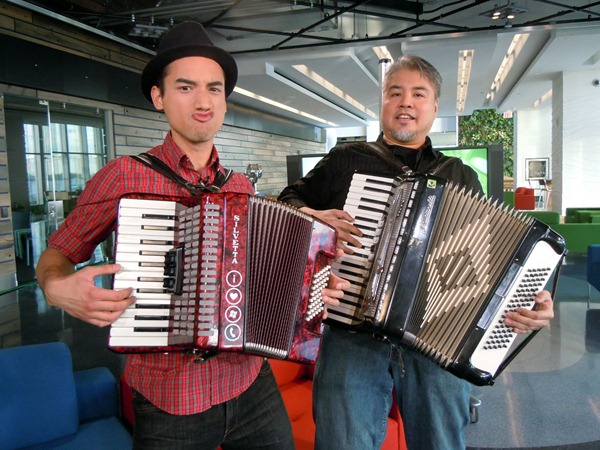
[313,327,471,450]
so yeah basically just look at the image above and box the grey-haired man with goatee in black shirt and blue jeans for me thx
[279,56,553,450]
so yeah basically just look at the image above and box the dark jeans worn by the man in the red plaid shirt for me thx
[133,361,294,450]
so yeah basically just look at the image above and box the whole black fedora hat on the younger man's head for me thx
[142,22,237,102]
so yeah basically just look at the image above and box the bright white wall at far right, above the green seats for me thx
[515,71,600,215]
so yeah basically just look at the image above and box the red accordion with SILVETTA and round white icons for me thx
[109,193,337,363]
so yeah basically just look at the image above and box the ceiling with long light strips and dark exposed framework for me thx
[13,0,600,127]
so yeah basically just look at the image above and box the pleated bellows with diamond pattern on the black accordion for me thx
[407,185,531,366]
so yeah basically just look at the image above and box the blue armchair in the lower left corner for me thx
[0,342,132,450]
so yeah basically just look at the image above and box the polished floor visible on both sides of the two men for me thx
[0,257,600,450]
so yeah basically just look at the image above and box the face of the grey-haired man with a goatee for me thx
[381,69,438,148]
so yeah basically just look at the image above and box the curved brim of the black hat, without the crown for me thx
[141,45,238,103]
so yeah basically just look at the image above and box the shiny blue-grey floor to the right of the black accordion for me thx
[467,257,600,450]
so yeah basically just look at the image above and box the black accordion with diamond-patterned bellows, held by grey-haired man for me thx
[325,172,566,386]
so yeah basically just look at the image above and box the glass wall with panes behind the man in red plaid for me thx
[4,95,108,283]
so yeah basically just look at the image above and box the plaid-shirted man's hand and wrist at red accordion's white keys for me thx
[37,248,135,327]
